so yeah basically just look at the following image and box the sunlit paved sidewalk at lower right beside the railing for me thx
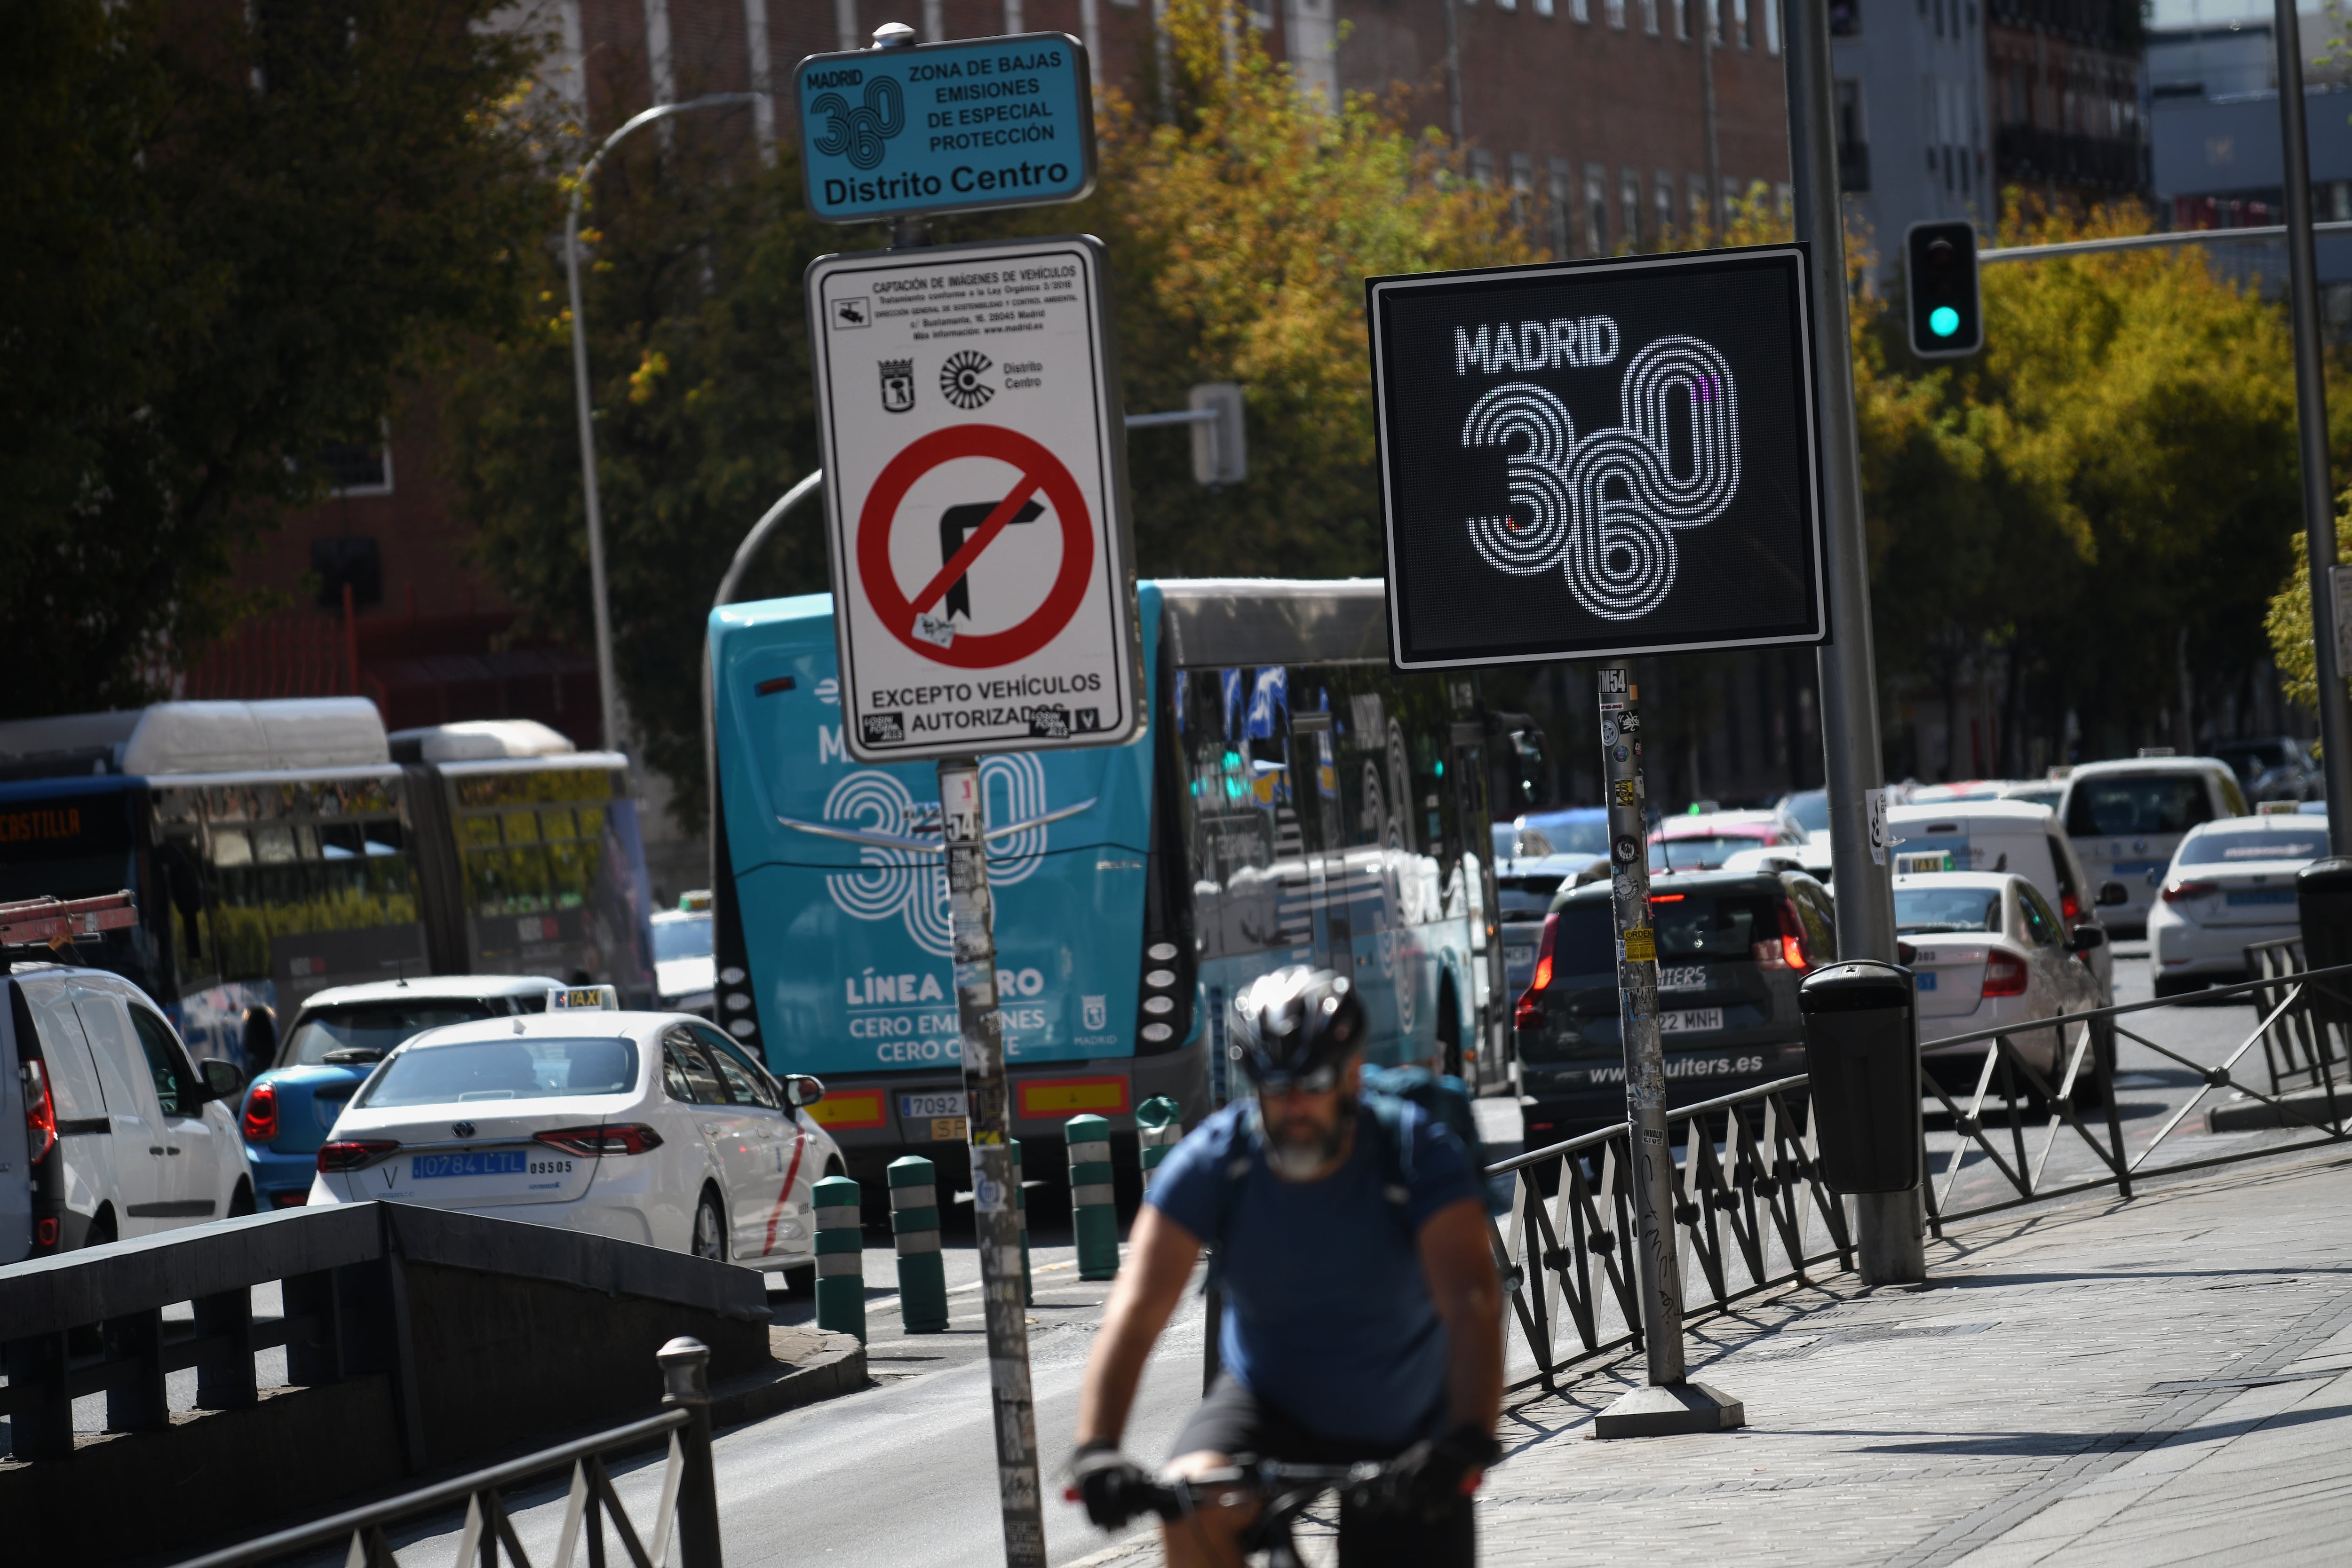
[1089,1149,2352,1568]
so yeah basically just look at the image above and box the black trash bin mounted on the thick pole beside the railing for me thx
[1797,959,1919,1192]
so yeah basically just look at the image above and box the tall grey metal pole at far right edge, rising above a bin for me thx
[2272,0,2352,855]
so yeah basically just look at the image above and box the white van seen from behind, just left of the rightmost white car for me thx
[2058,757,2249,938]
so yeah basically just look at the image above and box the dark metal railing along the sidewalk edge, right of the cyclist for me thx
[1486,942,2352,1387]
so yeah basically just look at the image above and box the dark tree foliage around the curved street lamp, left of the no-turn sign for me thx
[449,133,844,820]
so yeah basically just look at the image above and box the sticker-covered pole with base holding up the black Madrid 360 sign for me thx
[1595,665,1748,1436]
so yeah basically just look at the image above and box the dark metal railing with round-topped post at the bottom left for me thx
[181,1338,722,1568]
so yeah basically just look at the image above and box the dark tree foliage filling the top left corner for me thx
[0,0,548,715]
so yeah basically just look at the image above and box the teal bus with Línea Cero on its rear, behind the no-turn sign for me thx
[708,581,1508,1192]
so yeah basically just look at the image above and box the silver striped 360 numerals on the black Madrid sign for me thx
[1463,333,1740,621]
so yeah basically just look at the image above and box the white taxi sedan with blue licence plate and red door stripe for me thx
[310,1008,844,1288]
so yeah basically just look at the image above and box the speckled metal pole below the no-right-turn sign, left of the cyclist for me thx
[938,757,1044,1568]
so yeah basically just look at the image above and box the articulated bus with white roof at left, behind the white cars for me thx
[0,698,654,1060]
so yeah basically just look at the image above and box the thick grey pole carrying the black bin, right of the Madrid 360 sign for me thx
[1780,0,1926,1286]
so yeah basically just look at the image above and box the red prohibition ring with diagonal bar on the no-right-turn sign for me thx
[858,426,1094,670]
